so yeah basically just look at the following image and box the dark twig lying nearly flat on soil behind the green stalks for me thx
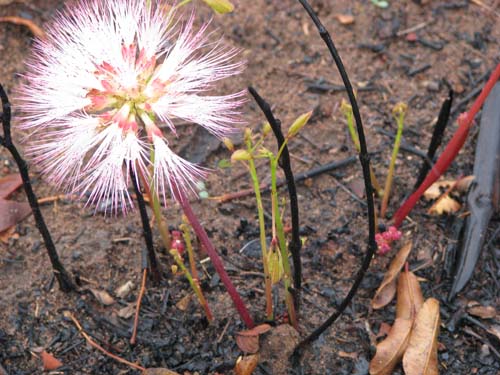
[212,156,356,203]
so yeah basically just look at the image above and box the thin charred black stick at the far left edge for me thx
[0,85,77,292]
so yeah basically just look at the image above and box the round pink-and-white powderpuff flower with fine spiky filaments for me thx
[16,0,244,213]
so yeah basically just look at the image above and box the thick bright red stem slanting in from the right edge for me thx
[394,64,500,227]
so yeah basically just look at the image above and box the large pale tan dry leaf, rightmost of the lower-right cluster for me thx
[403,298,440,375]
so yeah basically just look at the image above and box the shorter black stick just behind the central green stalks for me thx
[248,86,302,289]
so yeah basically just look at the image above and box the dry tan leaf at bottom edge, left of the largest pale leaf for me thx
[370,318,413,375]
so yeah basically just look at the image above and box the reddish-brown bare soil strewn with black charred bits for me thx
[0,0,500,375]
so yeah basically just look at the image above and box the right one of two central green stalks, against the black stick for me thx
[270,156,298,329]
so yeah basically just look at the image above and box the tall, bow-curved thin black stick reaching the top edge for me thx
[294,0,377,352]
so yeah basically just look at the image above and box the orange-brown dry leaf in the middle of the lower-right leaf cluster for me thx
[396,272,424,320]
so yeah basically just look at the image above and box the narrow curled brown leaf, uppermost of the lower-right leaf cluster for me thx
[372,241,412,310]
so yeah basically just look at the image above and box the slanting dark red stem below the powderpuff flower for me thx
[172,184,254,328]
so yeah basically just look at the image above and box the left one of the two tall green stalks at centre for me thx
[248,153,273,320]
